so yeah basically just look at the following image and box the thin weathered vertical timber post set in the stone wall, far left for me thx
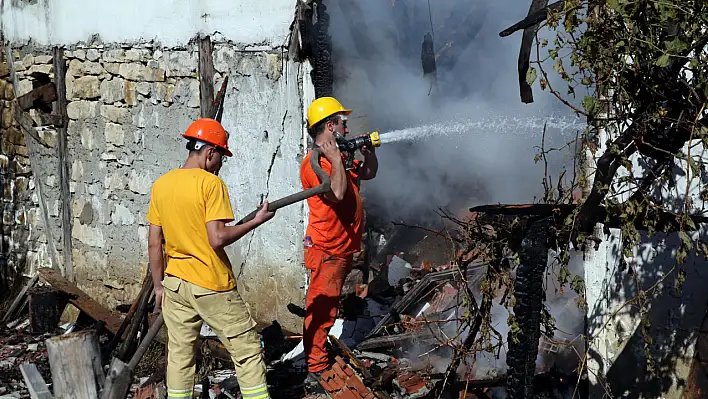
[53,47,74,282]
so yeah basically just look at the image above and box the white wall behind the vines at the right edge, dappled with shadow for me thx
[584,128,708,398]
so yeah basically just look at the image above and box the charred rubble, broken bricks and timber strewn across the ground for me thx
[0,219,578,399]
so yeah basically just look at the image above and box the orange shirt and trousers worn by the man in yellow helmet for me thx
[300,151,364,373]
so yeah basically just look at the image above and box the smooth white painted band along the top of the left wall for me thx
[2,0,297,46]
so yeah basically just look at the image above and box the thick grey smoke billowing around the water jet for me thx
[325,0,583,223]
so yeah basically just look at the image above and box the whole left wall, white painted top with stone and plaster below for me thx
[2,1,312,331]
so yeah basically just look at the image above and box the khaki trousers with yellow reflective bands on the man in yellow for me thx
[162,276,269,399]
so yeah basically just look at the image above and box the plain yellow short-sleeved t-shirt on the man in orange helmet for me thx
[147,168,236,291]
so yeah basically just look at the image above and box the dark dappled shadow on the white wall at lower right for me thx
[588,227,708,398]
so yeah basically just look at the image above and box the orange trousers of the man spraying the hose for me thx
[302,248,353,373]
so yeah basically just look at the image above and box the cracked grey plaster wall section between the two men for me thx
[214,45,308,331]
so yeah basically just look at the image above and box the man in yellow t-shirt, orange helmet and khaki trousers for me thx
[147,118,274,399]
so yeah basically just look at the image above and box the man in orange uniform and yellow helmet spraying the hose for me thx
[300,97,378,382]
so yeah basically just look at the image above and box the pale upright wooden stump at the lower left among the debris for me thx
[45,330,105,399]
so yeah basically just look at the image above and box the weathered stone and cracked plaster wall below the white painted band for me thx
[4,41,305,330]
